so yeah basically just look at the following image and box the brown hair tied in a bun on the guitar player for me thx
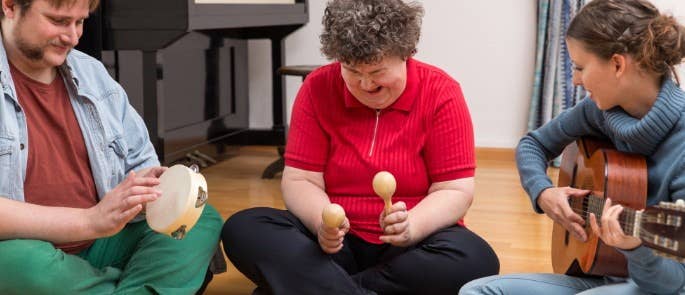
[566,0,685,80]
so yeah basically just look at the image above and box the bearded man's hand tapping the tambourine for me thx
[86,169,161,237]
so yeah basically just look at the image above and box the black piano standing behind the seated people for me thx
[77,0,309,164]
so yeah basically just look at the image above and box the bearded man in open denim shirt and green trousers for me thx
[0,0,222,294]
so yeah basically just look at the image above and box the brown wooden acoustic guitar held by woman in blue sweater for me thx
[552,138,685,277]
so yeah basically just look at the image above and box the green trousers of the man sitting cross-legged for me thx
[0,205,223,295]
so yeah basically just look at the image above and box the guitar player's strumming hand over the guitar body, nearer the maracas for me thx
[537,187,590,242]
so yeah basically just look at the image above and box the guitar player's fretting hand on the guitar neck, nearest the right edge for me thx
[590,198,642,250]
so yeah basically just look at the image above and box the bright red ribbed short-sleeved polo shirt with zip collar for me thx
[285,59,475,244]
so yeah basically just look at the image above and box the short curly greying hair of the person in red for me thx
[320,0,423,64]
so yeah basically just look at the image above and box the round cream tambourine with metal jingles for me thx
[145,165,207,240]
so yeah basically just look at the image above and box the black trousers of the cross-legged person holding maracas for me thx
[221,208,499,295]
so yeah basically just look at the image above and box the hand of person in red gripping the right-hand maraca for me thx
[379,201,414,247]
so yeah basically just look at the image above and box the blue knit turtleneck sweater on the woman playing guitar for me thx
[516,79,685,294]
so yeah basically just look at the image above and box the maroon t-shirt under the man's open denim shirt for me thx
[10,65,97,253]
